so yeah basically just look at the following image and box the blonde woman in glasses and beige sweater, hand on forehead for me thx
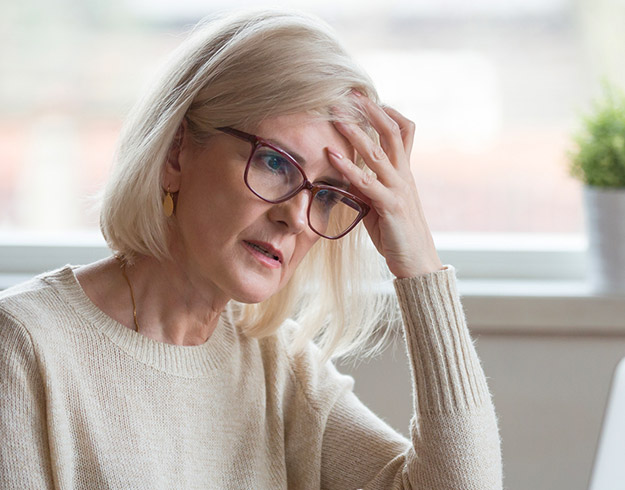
[0,8,501,490]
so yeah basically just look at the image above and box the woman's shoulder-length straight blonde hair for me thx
[100,10,394,359]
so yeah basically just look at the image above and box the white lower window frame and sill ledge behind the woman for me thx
[0,232,625,335]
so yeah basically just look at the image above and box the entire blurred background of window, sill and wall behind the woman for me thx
[0,0,625,490]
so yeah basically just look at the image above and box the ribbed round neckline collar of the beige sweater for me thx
[43,265,237,378]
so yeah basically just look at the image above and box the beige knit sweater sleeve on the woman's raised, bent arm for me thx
[322,267,502,490]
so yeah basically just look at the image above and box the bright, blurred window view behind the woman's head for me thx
[0,0,625,235]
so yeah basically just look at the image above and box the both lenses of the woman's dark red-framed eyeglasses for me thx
[247,145,362,238]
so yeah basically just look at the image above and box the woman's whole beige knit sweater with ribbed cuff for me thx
[0,267,502,490]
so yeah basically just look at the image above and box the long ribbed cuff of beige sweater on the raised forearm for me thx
[394,266,490,414]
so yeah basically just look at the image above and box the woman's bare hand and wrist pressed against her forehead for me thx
[328,94,443,278]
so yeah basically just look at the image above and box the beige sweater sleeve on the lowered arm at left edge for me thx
[0,309,53,489]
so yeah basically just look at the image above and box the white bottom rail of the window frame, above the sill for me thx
[0,231,587,287]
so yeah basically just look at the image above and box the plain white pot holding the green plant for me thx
[584,186,625,294]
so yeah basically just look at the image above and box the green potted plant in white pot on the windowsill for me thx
[570,83,625,294]
